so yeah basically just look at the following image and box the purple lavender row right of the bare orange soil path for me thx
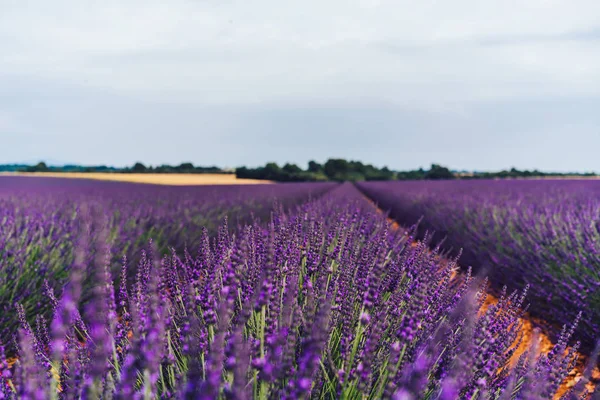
[359,180,600,347]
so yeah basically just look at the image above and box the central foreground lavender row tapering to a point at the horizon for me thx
[0,184,583,400]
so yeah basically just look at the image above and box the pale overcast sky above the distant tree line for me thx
[0,0,600,172]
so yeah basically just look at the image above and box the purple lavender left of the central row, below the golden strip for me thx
[0,177,335,340]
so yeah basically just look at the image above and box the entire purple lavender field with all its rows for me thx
[0,177,600,400]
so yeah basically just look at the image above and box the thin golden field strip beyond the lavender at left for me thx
[0,172,272,186]
